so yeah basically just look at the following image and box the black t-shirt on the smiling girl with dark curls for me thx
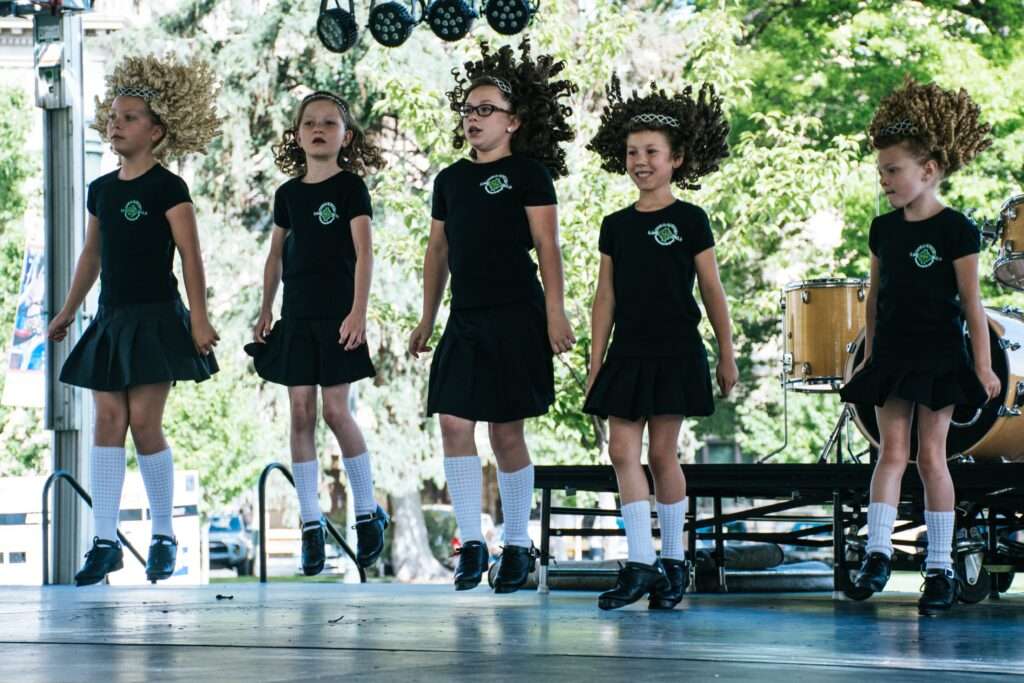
[599,201,715,355]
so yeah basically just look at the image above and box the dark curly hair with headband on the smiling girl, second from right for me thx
[587,75,729,189]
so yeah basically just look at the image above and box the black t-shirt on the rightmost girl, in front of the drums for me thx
[868,208,981,357]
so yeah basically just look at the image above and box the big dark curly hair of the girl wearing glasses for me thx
[445,38,577,178]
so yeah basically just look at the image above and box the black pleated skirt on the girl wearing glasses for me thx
[427,301,555,422]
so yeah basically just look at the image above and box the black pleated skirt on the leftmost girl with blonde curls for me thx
[60,299,218,391]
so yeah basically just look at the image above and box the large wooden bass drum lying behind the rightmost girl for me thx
[845,308,1024,462]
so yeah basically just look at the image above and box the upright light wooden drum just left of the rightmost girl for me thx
[781,279,867,391]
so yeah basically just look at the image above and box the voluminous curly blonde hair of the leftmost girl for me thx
[92,54,220,161]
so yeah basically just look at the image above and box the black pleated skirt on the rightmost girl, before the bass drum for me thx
[840,349,987,411]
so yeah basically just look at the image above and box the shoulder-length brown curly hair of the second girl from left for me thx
[271,90,385,176]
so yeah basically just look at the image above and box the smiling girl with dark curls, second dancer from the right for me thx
[584,77,738,609]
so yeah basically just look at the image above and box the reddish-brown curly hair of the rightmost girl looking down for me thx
[868,76,992,176]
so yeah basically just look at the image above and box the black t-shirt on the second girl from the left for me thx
[273,171,373,318]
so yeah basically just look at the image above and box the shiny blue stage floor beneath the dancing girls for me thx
[0,583,1024,683]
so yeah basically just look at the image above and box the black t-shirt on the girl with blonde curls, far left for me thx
[86,164,191,306]
